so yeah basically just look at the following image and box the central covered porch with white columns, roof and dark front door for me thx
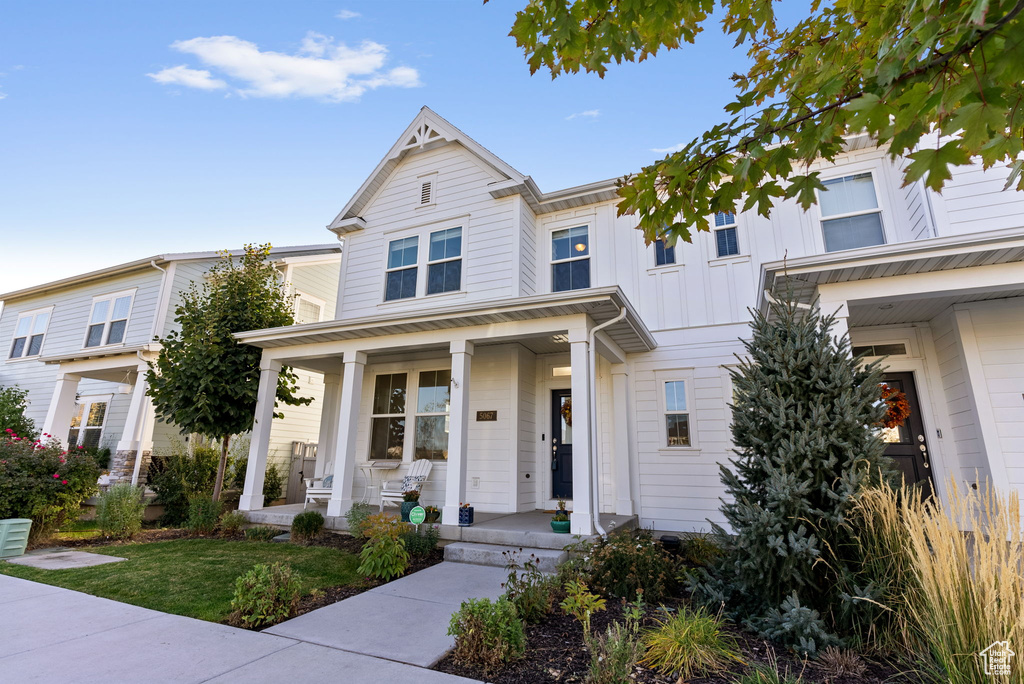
[238,288,654,536]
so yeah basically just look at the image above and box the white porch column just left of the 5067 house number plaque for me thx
[441,341,473,525]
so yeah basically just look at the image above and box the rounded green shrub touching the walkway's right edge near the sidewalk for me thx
[447,598,526,668]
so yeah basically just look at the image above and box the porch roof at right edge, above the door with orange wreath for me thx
[758,227,1024,311]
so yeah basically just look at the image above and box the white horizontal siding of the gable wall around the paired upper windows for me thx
[338,144,520,318]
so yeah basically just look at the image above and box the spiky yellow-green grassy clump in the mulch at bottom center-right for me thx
[641,607,742,681]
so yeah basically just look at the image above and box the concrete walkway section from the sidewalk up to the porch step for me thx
[264,563,508,668]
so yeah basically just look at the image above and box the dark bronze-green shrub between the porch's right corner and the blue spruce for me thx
[590,529,673,602]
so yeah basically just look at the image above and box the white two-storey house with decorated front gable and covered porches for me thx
[232,108,1024,533]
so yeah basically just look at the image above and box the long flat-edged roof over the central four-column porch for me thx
[234,286,657,352]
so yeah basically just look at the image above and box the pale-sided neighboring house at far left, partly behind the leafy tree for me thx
[0,244,341,501]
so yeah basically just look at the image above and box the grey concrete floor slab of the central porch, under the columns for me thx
[246,504,637,549]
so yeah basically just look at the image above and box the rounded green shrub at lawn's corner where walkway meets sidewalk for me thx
[229,563,300,629]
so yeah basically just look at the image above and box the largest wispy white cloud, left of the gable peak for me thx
[148,32,420,102]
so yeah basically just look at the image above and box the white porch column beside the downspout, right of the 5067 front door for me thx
[569,328,594,535]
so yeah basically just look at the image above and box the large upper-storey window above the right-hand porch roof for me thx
[818,173,886,252]
